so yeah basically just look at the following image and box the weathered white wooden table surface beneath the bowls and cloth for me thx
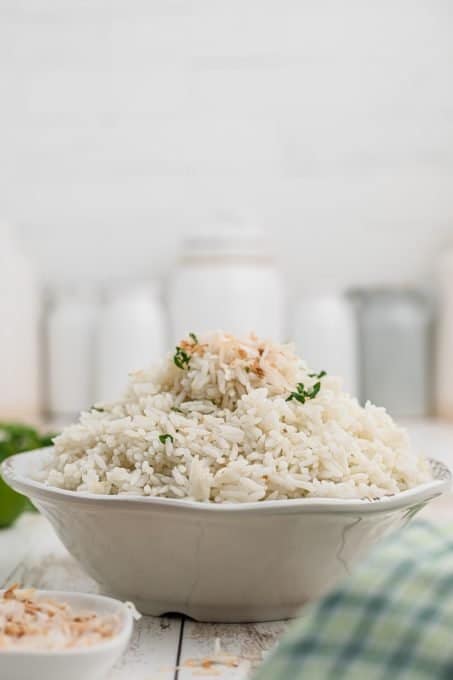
[0,422,453,680]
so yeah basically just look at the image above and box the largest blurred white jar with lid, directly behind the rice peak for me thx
[169,229,285,342]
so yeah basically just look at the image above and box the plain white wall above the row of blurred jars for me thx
[0,0,453,288]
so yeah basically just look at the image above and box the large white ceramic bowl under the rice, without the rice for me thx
[2,449,451,622]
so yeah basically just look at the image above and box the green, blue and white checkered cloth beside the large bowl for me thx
[254,521,453,680]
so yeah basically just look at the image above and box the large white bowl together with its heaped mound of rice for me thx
[2,331,451,621]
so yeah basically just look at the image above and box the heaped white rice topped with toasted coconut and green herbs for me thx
[41,332,431,503]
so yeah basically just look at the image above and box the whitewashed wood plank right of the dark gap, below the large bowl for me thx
[178,620,287,680]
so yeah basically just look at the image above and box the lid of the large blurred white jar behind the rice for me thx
[182,225,269,257]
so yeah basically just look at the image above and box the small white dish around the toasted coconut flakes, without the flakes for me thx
[0,590,133,680]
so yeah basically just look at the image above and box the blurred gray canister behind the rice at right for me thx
[353,288,432,417]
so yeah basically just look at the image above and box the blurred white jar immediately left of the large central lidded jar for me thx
[95,281,167,402]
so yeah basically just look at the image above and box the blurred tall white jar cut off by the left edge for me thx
[0,223,40,419]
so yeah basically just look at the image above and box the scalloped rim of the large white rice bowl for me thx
[0,446,452,514]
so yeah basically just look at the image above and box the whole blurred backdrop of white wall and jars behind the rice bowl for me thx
[0,0,453,423]
